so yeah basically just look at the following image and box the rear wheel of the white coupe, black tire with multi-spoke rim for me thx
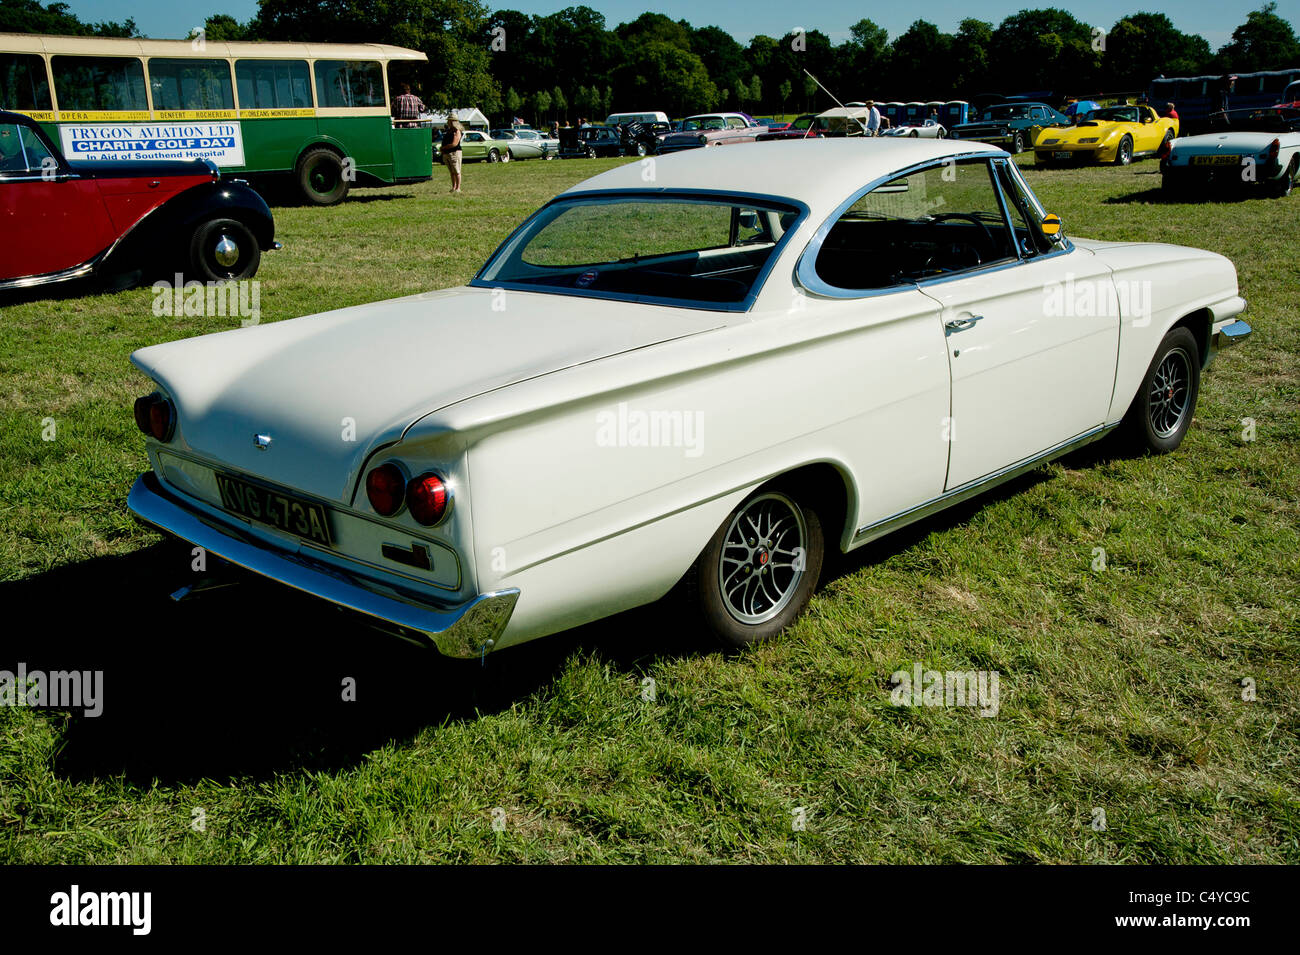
[685,487,826,650]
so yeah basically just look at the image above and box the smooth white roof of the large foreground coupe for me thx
[562,136,1002,222]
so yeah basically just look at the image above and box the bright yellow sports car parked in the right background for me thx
[1034,107,1178,166]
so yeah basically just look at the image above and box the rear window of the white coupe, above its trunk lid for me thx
[476,195,800,308]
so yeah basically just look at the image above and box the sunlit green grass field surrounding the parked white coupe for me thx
[0,156,1300,864]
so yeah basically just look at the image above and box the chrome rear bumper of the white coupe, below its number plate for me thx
[126,472,519,659]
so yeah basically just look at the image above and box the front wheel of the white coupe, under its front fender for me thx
[1118,327,1201,455]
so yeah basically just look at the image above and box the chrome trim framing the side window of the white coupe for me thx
[794,149,1074,299]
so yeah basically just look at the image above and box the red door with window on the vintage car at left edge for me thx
[0,123,117,281]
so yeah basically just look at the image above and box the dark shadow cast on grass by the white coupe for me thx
[0,444,1128,786]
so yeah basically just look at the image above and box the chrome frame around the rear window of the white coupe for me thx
[468,188,809,312]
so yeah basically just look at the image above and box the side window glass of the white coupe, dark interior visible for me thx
[814,159,1017,290]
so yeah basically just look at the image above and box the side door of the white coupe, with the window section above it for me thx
[919,159,1119,491]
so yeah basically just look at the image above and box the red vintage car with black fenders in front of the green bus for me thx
[0,112,280,290]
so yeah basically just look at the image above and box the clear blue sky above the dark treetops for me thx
[58,0,1300,49]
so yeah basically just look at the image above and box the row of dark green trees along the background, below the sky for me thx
[0,0,1300,122]
